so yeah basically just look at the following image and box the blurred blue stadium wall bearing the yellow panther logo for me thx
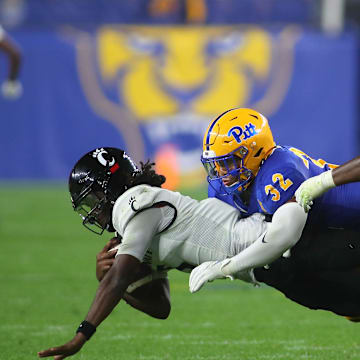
[0,25,359,188]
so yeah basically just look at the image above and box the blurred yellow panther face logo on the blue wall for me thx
[77,26,298,187]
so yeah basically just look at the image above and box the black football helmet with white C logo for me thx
[69,147,139,235]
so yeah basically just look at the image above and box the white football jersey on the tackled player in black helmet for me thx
[112,185,267,278]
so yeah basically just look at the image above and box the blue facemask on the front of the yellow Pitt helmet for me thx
[201,146,254,195]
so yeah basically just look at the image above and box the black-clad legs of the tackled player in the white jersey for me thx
[254,229,360,317]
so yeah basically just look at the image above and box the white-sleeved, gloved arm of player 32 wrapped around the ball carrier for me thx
[189,202,307,292]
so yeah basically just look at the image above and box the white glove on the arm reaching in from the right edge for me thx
[295,170,335,212]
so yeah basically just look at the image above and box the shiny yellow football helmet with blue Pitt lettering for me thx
[201,108,276,194]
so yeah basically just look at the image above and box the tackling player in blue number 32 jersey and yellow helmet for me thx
[190,108,360,292]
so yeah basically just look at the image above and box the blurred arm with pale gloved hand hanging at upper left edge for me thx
[0,25,22,100]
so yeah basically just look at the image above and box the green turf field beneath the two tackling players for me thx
[0,184,360,360]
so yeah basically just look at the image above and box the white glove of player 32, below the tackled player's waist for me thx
[189,259,234,293]
